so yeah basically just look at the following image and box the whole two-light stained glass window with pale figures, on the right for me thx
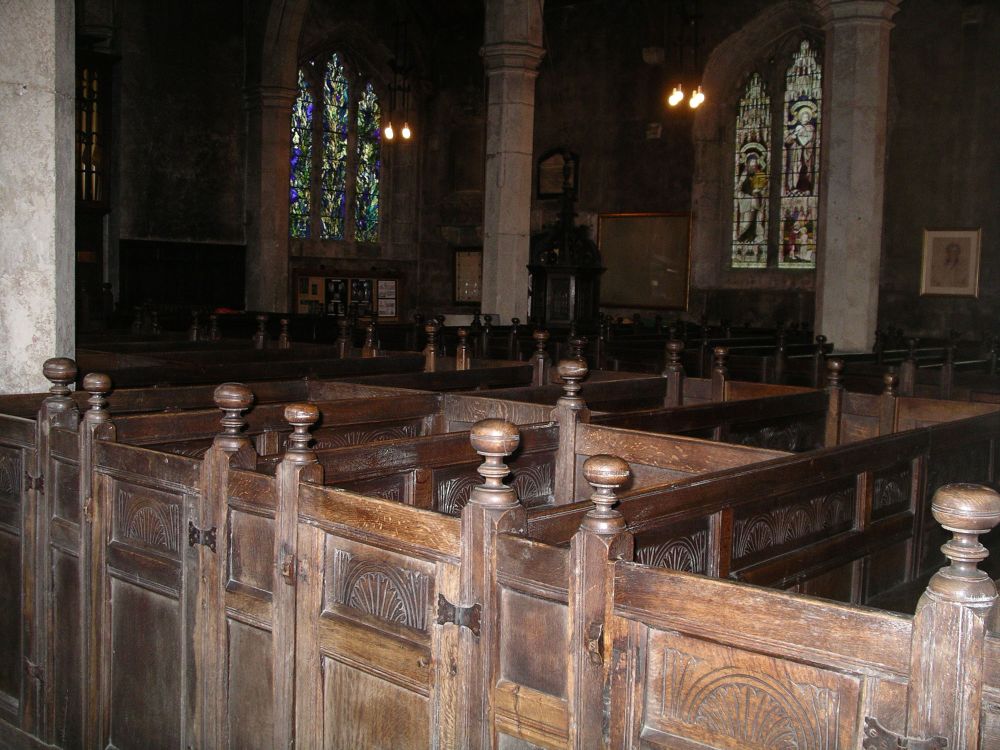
[731,40,823,269]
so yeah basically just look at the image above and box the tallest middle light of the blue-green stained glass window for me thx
[320,54,350,240]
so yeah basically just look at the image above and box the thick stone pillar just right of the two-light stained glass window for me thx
[815,0,902,351]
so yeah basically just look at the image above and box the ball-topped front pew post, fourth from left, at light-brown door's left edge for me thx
[271,403,323,747]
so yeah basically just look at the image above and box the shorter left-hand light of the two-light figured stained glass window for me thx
[732,73,771,268]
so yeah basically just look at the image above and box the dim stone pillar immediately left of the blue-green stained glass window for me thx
[246,86,296,312]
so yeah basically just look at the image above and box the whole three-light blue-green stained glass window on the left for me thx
[288,52,382,242]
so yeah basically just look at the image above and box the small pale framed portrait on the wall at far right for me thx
[920,229,982,297]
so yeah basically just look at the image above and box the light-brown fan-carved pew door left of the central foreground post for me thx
[295,483,460,750]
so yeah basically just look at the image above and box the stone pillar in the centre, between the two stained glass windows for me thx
[482,0,545,323]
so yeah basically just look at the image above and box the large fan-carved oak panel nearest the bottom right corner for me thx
[646,632,860,750]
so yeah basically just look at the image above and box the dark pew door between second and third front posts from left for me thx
[83,441,207,750]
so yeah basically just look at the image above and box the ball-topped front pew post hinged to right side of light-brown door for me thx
[458,419,527,749]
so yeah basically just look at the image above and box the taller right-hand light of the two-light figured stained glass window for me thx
[778,41,823,268]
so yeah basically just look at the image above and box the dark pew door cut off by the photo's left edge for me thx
[0,416,36,726]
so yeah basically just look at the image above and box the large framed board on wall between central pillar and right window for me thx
[597,212,691,310]
